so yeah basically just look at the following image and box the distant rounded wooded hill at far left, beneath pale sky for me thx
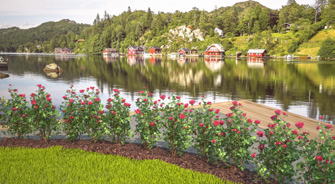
[0,19,89,52]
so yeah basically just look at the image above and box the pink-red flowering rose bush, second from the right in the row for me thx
[254,110,303,183]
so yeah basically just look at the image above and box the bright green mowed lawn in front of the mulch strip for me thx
[0,146,238,184]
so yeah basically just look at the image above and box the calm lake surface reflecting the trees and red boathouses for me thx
[0,53,335,124]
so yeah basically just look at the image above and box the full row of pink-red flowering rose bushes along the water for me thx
[0,85,335,183]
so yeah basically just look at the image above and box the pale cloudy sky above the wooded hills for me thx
[0,0,315,29]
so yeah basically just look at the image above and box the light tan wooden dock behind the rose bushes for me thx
[0,100,335,138]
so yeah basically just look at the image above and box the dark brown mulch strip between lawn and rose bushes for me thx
[0,138,263,184]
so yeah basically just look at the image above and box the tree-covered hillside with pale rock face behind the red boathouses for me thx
[0,0,335,55]
